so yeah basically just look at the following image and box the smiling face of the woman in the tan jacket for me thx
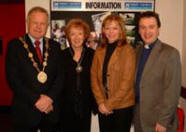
[103,21,121,43]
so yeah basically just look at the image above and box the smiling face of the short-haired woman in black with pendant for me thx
[69,26,85,48]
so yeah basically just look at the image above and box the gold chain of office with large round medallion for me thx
[19,37,49,83]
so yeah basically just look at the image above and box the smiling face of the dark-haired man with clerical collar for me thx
[139,17,159,45]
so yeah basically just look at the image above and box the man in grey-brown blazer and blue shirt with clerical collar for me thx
[134,11,181,132]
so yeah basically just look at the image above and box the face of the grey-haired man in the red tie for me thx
[27,11,48,40]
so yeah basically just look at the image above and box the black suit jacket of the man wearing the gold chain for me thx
[6,35,63,126]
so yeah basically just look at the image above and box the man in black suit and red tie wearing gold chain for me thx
[6,7,63,132]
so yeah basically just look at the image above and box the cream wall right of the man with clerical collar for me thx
[155,0,184,57]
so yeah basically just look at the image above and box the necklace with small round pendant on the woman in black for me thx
[69,47,85,73]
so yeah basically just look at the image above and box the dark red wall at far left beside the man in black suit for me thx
[0,2,25,106]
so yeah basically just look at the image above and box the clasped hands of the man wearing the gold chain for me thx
[35,94,53,113]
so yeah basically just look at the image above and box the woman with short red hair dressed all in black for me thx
[61,19,94,132]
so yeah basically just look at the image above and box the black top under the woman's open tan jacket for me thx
[103,41,118,97]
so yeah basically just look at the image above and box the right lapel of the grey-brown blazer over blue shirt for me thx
[142,40,161,79]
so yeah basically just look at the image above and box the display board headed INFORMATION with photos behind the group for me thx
[50,0,155,49]
